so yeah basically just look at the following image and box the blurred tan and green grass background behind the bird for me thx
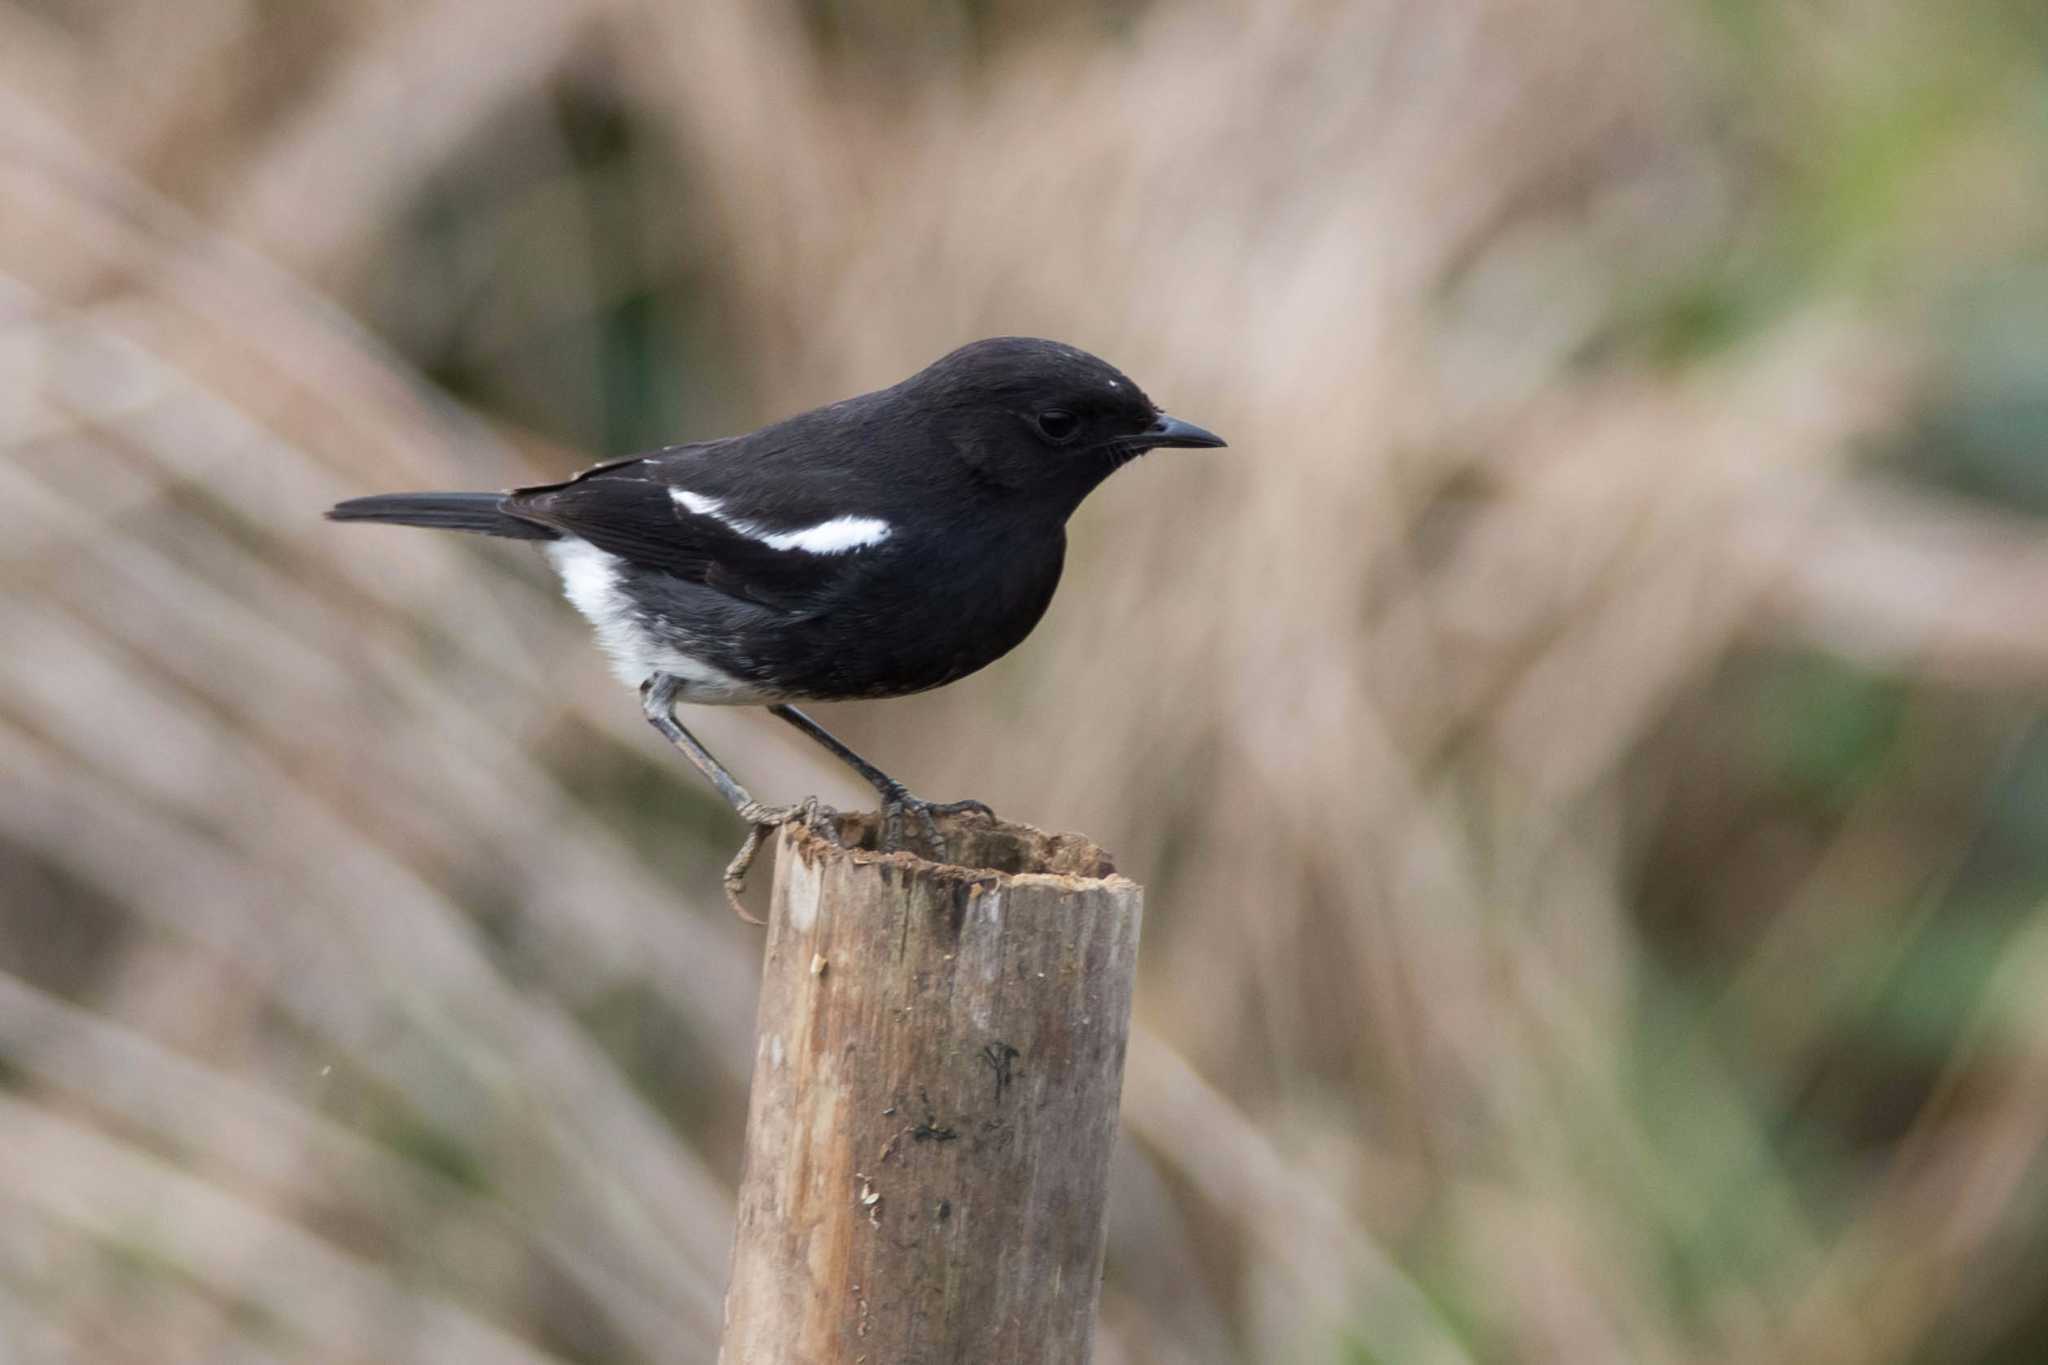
[0,0,2048,1365]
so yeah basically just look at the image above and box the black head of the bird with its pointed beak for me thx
[899,336,1223,516]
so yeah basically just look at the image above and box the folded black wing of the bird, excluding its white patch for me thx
[502,442,884,612]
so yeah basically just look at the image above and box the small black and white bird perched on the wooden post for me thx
[328,338,1223,888]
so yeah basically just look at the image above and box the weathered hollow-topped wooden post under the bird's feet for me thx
[719,817,1143,1365]
